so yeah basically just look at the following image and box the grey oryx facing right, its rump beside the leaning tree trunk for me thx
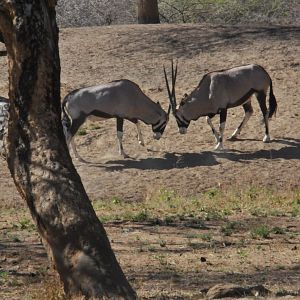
[62,79,171,161]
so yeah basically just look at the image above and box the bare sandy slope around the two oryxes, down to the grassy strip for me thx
[60,25,300,200]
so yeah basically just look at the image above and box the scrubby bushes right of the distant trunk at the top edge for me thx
[160,0,298,24]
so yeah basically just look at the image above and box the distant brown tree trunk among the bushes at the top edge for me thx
[138,0,159,24]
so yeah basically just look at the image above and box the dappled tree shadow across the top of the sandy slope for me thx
[114,24,300,58]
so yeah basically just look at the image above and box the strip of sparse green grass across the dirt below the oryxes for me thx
[93,187,300,223]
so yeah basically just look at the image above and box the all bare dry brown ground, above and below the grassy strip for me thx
[0,25,300,299]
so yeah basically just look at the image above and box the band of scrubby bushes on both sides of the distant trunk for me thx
[57,0,299,27]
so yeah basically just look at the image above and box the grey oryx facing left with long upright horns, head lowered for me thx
[164,61,277,150]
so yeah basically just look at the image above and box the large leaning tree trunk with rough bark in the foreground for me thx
[0,0,136,299]
